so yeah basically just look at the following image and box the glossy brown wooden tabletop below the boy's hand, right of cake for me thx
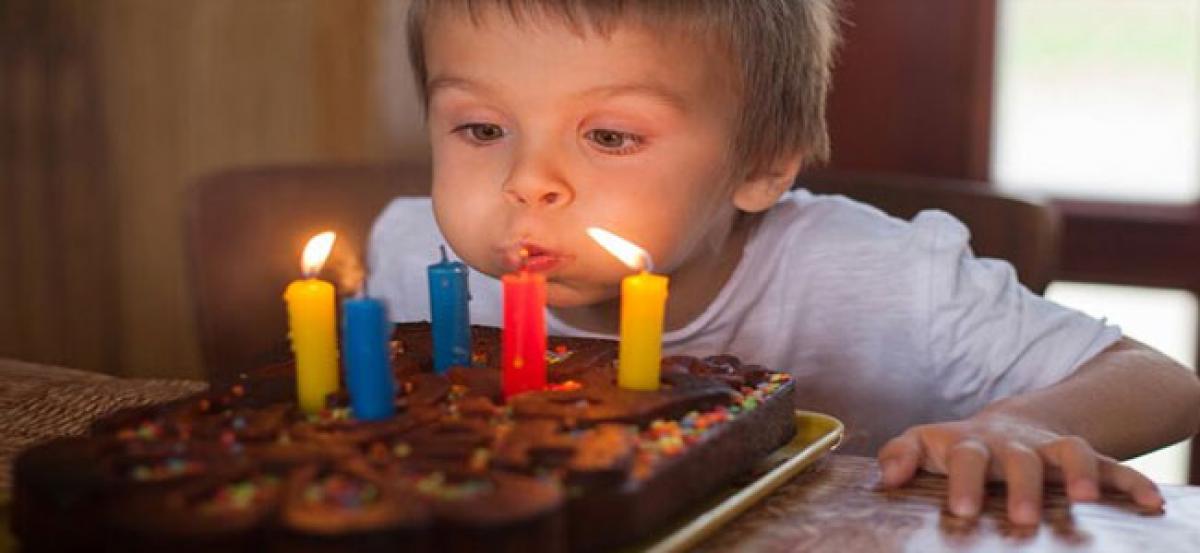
[700,455,1200,553]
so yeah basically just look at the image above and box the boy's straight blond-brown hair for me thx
[408,0,838,174]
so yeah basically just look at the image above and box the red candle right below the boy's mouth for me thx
[500,269,546,398]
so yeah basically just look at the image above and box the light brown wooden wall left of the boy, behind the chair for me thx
[0,0,426,378]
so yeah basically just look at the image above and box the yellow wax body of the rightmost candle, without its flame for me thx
[617,271,667,391]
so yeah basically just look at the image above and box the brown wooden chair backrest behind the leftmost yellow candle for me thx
[185,164,430,383]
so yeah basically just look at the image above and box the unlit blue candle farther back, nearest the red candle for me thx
[428,246,470,374]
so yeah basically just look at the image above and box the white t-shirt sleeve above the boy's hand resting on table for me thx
[913,211,1121,417]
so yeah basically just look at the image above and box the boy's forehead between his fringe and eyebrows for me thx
[424,8,736,107]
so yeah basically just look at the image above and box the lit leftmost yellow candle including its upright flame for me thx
[283,233,337,413]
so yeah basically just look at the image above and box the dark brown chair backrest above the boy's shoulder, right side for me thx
[797,170,1060,294]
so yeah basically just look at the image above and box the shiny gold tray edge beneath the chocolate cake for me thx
[620,409,846,553]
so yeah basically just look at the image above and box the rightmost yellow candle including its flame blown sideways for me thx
[588,227,670,391]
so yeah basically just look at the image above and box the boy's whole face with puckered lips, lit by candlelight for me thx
[426,11,737,307]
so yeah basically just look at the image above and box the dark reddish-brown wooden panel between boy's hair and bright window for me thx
[829,0,996,180]
